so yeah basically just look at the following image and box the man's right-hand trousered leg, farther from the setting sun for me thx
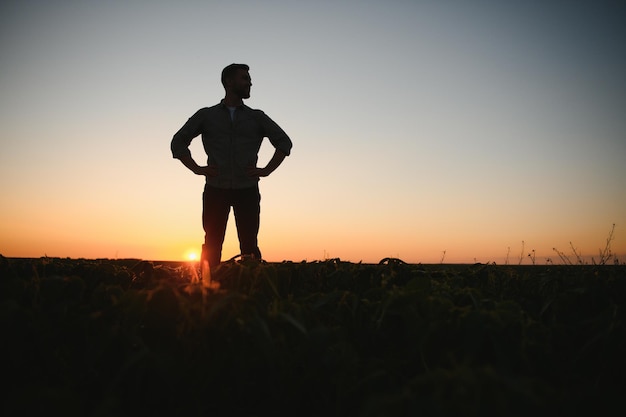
[233,186,261,260]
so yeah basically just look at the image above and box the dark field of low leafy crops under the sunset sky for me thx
[0,256,626,417]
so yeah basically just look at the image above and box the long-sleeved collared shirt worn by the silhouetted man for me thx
[171,102,292,188]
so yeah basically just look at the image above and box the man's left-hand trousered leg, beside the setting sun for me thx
[202,185,230,268]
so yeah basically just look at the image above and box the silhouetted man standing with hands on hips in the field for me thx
[171,64,292,269]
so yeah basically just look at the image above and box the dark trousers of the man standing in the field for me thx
[202,185,261,268]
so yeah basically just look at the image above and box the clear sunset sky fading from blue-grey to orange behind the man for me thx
[0,0,626,264]
